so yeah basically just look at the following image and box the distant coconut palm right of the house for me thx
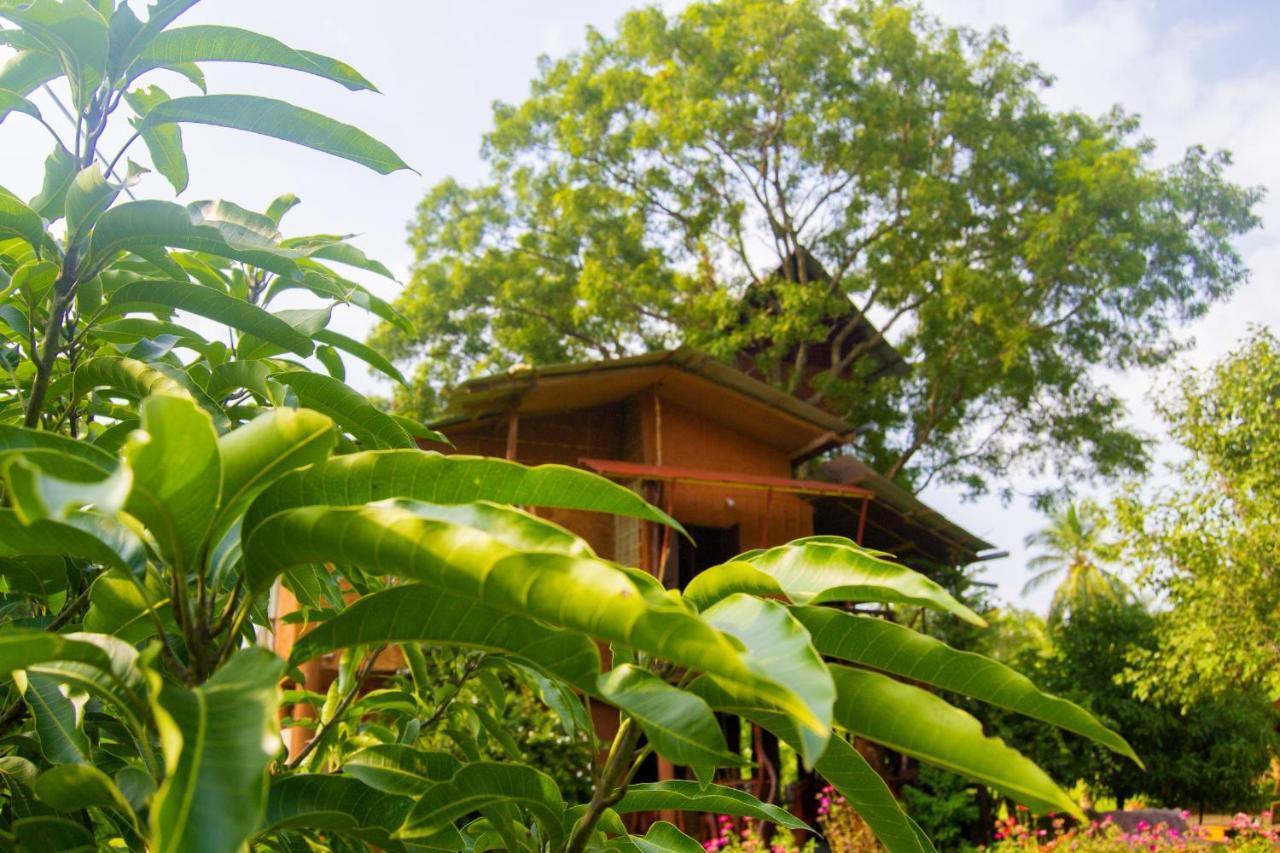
[1023,502,1132,622]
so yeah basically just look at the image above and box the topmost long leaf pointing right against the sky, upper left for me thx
[140,26,378,91]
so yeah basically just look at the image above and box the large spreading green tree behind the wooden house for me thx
[375,0,1258,491]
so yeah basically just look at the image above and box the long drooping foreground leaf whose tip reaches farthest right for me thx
[791,607,1142,765]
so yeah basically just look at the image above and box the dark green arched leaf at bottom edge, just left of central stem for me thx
[397,761,564,849]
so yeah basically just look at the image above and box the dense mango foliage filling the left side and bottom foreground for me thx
[0,0,1133,853]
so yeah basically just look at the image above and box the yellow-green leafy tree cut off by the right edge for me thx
[1116,330,1280,701]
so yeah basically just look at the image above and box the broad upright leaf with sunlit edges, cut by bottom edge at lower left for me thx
[148,648,284,853]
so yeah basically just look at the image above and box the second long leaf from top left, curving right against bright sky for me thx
[141,95,408,174]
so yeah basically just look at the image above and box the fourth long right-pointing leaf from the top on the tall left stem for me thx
[106,282,312,356]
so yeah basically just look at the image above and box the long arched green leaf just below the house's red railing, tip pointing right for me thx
[244,450,682,532]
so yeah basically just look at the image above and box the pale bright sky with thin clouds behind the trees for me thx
[0,0,1280,610]
